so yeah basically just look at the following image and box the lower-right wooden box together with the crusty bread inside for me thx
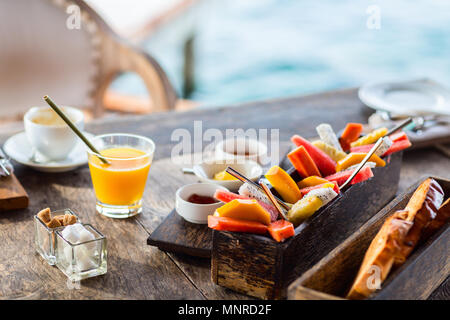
[289,177,450,300]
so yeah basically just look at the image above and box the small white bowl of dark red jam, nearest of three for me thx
[175,183,228,224]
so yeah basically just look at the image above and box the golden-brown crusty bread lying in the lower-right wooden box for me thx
[347,178,444,299]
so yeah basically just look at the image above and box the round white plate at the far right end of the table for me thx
[358,79,450,116]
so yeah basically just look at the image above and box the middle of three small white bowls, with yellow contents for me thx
[192,159,263,191]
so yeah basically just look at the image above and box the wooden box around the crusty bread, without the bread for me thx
[289,177,450,300]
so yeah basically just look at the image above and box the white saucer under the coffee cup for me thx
[3,132,94,172]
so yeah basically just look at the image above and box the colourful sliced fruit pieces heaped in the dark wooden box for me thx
[208,123,411,242]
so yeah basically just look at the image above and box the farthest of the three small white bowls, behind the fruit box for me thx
[215,137,267,162]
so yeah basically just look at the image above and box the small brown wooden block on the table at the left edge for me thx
[0,174,29,211]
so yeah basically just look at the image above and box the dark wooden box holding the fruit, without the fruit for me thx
[211,152,402,299]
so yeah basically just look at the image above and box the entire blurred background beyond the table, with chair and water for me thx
[0,0,450,125]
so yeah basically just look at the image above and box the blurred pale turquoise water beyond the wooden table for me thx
[115,0,450,106]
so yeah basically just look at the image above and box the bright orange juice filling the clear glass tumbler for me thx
[89,147,151,206]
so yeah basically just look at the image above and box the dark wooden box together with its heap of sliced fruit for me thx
[208,123,411,299]
